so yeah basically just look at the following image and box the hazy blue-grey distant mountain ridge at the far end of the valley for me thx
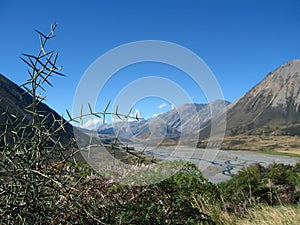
[97,100,230,145]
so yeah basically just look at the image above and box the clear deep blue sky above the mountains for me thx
[0,0,300,124]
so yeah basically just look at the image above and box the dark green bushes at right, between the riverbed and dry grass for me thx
[219,163,300,213]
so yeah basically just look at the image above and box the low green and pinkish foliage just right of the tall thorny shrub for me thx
[73,162,220,224]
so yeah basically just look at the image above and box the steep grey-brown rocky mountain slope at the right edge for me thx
[203,60,300,135]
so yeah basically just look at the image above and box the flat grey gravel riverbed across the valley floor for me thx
[134,146,299,183]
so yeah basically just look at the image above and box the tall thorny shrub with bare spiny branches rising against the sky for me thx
[0,23,144,224]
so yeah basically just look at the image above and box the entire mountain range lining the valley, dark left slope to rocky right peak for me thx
[0,60,300,153]
